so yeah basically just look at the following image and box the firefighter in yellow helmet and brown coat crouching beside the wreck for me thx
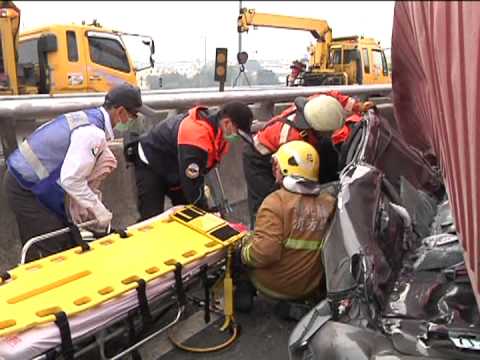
[241,140,336,306]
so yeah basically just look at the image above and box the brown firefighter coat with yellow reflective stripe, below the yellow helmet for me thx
[241,181,336,299]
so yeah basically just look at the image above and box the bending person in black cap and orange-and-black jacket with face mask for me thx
[126,102,253,220]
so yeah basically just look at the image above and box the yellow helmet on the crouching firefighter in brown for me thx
[273,140,320,181]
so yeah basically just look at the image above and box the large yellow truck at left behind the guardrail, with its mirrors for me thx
[0,1,155,95]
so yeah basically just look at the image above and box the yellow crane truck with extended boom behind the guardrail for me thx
[237,8,391,86]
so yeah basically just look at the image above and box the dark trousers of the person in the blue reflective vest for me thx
[4,171,74,261]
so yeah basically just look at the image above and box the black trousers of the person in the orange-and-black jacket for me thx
[134,160,187,220]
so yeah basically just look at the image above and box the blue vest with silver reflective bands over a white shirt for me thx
[7,108,105,221]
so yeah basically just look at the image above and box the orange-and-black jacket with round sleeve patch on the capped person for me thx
[139,106,229,207]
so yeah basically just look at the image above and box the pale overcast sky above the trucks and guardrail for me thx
[16,1,394,61]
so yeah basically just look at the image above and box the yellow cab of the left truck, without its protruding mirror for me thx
[18,24,152,94]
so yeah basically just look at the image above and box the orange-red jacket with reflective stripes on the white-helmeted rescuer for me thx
[253,91,361,155]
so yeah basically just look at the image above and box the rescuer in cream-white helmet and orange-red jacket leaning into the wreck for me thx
[243,91,374,227]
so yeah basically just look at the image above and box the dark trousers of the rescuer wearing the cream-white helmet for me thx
[242,146,279,229]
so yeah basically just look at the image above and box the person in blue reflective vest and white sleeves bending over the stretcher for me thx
[4,83,143,260]
